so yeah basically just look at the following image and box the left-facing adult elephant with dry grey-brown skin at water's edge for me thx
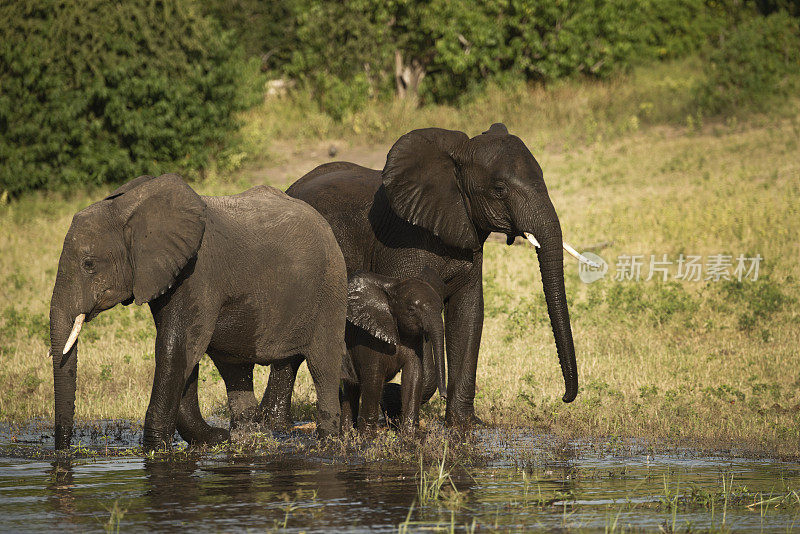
[50,174,347,450]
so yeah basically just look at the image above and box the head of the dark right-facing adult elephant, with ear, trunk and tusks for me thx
[382,124,588,402]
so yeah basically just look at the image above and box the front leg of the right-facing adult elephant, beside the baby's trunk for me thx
[445,270,483,426]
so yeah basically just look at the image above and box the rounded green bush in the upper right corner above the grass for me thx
[697,12,800,114]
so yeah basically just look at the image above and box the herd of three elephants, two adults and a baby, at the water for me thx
[50,124,592,451]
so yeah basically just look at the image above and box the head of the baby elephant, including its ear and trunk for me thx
[347,272,447,398]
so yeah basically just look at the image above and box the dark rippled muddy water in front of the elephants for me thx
[0,425,800,532]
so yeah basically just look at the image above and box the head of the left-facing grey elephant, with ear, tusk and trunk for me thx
[50,174,206,449]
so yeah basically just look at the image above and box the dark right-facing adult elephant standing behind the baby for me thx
[264,124,592,427]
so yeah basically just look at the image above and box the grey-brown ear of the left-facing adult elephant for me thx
[110,174,206,304]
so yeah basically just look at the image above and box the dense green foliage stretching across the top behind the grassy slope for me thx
[0,0,800,199]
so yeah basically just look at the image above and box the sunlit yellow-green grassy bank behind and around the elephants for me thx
[0,62,800,455]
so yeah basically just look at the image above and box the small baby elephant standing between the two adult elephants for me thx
[341,272,446,431]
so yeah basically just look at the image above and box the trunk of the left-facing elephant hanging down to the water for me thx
[50,304,78,450]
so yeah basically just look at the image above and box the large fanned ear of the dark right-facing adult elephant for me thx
[381,128,478,249]
